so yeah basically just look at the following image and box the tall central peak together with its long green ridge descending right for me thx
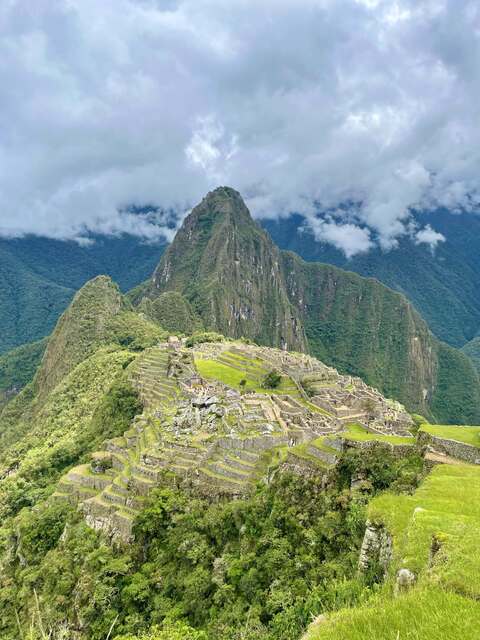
[144,187,480,423]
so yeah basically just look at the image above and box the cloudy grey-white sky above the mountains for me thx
[0,0,480,257]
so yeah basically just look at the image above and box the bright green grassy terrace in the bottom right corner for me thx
[305,464,480,640]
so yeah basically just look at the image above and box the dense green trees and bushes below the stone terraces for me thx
[0,444,421,640]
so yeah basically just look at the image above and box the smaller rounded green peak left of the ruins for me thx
[35,276,126,397]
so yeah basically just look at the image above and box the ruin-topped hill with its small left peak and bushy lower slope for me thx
[0,277,417,640]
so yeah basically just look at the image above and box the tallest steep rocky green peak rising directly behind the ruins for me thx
[148,187,306,351]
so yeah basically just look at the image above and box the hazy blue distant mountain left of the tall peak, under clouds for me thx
[0,235,165,353]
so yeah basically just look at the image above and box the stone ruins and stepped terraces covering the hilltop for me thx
[54,340,412,541]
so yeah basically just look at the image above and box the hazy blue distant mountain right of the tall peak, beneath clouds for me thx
[262,209,480,347]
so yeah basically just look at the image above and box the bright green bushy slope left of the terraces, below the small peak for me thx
[0,348,139,518]
